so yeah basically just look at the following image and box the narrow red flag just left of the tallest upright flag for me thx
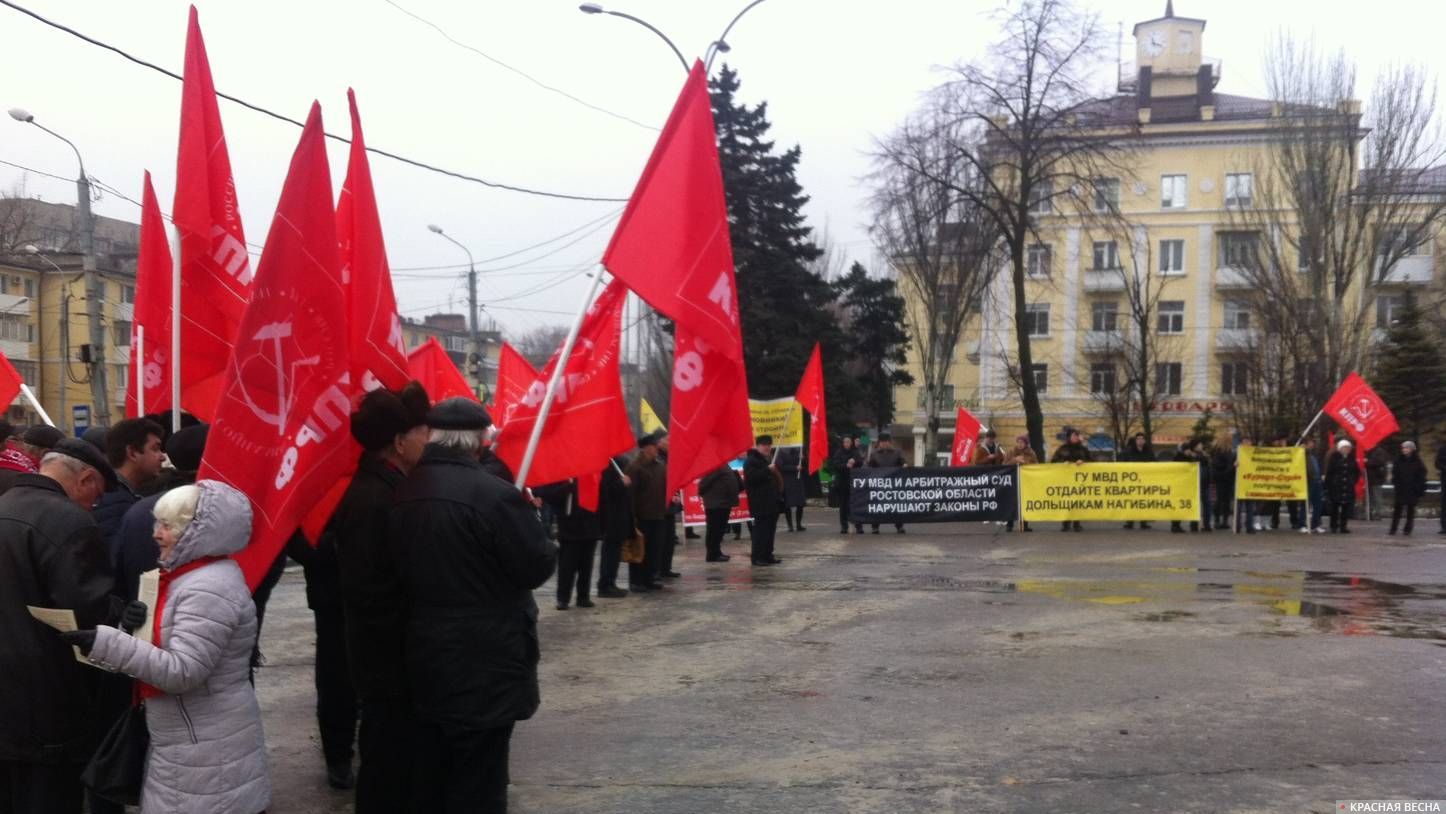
[126,172,172,418]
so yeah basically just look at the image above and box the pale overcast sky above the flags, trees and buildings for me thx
[0,0,1446,338]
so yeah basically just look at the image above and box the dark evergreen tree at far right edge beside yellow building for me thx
[1371,296,1446,438]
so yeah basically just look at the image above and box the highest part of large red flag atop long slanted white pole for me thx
[603,62,743,365]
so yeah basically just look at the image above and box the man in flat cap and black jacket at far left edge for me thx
[0,438,116,814]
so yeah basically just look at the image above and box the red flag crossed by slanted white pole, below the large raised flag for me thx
[492,280,635,486]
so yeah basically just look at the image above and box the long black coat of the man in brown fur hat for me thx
[329,454,406,701]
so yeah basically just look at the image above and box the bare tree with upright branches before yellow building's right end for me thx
[1220,35,1446,419]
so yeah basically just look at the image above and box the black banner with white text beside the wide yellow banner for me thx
[849,467,1019,523]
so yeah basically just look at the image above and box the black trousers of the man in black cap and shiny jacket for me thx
[412,723,513,814]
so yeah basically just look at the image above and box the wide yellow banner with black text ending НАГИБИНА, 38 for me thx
[1019,463,1200,520]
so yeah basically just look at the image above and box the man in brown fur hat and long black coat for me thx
[331,382,431,814]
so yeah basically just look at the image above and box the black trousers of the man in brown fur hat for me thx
[357,697,419,814]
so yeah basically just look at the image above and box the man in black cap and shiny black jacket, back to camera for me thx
[388,398,557,814]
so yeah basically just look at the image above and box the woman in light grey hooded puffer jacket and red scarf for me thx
[90,480,270,814]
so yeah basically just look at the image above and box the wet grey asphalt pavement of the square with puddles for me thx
[257,520,1446,814]
